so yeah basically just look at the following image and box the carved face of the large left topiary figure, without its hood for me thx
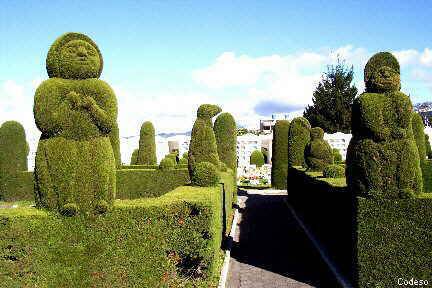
[60,40,101,79]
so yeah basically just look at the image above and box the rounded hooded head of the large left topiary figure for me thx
[46,32,103,79]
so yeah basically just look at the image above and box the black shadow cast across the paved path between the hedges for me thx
[231,190,340,288]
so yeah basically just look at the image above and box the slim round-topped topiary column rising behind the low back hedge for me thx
[137,121,157,165]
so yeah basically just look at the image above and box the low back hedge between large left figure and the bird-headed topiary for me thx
[116,168,190,199]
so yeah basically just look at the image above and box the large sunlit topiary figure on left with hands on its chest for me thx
[33,33,117,215]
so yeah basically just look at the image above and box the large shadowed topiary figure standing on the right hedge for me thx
[346,52,422,199]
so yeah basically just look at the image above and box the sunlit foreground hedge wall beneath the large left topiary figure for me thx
[0,181,235,287]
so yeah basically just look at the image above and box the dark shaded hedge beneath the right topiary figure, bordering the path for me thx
[288,167,432,287]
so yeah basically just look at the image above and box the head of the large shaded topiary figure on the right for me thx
[364,52,401,93]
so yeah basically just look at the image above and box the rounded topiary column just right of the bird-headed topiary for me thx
[213,113,237,171]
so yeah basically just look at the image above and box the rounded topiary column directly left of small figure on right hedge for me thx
[288,117,311,167]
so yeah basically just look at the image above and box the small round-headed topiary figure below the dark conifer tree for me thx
[305,127,333,171]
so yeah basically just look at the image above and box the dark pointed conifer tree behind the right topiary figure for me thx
[303,59,357,133]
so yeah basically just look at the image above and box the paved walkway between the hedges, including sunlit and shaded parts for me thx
[226,190,339,288]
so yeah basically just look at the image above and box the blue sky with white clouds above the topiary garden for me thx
[0,0,432,151]
